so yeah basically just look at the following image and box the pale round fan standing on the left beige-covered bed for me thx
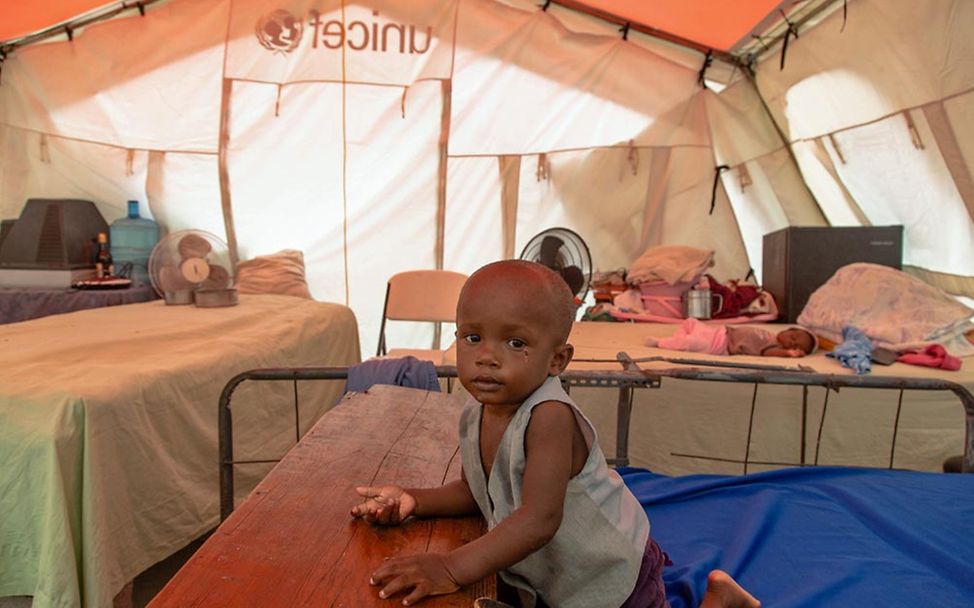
[149,230,237,307]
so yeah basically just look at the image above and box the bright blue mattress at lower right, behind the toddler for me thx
[619,467,974,608]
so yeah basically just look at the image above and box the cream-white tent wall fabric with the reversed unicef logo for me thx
[0,0,974,352]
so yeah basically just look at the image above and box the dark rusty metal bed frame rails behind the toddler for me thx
[218,352,974,521]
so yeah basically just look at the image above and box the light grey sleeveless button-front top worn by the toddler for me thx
[460,377,649,608]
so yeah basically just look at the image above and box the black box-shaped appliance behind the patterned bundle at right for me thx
[761,226,903,323]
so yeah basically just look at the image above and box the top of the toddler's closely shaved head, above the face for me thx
[457,260,575,344]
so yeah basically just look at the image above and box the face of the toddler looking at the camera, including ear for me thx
[456,289,571,405]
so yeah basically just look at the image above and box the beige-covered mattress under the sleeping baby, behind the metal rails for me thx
[570,323,974,475]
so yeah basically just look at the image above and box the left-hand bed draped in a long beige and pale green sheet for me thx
[0,295,360,608]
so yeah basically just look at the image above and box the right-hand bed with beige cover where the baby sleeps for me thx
[569,322,974,475]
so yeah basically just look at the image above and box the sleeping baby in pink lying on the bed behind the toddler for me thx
[646,319,818,357]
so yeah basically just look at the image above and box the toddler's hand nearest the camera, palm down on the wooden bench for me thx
[369,553,460,606]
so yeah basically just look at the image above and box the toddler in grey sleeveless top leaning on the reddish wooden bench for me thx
[352,261,760,608]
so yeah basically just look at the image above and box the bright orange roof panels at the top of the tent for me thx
[0,0,808,52]
